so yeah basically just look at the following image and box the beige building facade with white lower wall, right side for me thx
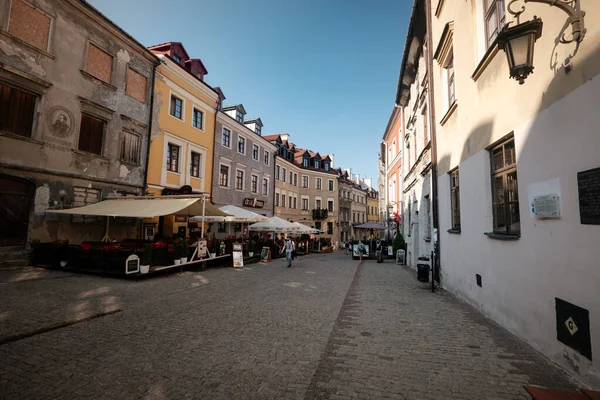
[428,0,600,385]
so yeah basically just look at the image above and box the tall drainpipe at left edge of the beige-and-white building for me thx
[425,0,441,272]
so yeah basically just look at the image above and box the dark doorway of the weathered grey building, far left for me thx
[0,175,34,246]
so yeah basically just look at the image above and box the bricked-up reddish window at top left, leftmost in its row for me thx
[8,0,50,50]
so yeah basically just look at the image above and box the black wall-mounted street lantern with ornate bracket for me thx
[498,0,586,85]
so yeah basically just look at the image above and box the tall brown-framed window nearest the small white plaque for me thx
[492,138,521,235]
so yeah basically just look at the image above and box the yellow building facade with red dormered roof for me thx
[144,42,219,238]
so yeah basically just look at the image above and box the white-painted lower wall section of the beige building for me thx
[438,77,600,385]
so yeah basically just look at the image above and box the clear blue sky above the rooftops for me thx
[91,0,412,186]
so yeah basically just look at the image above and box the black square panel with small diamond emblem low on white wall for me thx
[555,297,592,361]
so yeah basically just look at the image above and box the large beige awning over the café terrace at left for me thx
[46,196,229,219]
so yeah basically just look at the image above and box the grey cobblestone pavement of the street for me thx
[0,253,575,399]
